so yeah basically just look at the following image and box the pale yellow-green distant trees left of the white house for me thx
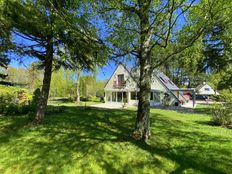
[2,63,105,101]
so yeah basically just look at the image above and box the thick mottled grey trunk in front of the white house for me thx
[133,1,153,141]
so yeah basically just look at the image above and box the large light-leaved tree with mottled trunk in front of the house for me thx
[98,0,222,140]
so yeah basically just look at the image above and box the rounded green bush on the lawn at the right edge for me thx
[212,102,232,128]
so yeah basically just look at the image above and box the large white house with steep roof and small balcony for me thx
[104,64,185,106]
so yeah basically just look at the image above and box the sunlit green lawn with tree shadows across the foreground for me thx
[0,105,232,174]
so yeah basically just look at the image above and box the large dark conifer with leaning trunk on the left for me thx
[5,0,107,123]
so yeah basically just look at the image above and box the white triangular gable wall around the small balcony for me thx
[104,64,137,91]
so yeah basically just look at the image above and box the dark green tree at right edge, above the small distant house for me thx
[176,0,232,89]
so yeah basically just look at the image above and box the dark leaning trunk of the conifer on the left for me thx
[34,40,53,123]
